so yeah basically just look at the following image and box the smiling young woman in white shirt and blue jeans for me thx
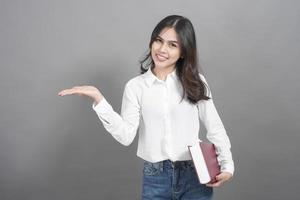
[59,15,234,200]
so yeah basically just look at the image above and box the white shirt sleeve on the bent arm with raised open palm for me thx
[92,81,140,146]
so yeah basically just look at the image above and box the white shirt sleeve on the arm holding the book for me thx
[197,74,234,174]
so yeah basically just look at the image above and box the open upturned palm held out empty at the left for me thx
[58,85,103,104]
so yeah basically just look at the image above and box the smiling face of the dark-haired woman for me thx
[151,27,180,69]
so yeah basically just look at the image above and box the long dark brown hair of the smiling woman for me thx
[140,15,210,104]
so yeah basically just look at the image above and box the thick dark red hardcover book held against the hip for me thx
[188,141,221,184]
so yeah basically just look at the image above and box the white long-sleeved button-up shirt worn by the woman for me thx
[92,68,234,174]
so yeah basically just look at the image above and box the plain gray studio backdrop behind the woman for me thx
[0,0,300,200]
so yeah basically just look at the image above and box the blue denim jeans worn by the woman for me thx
[142,160,213,200]
